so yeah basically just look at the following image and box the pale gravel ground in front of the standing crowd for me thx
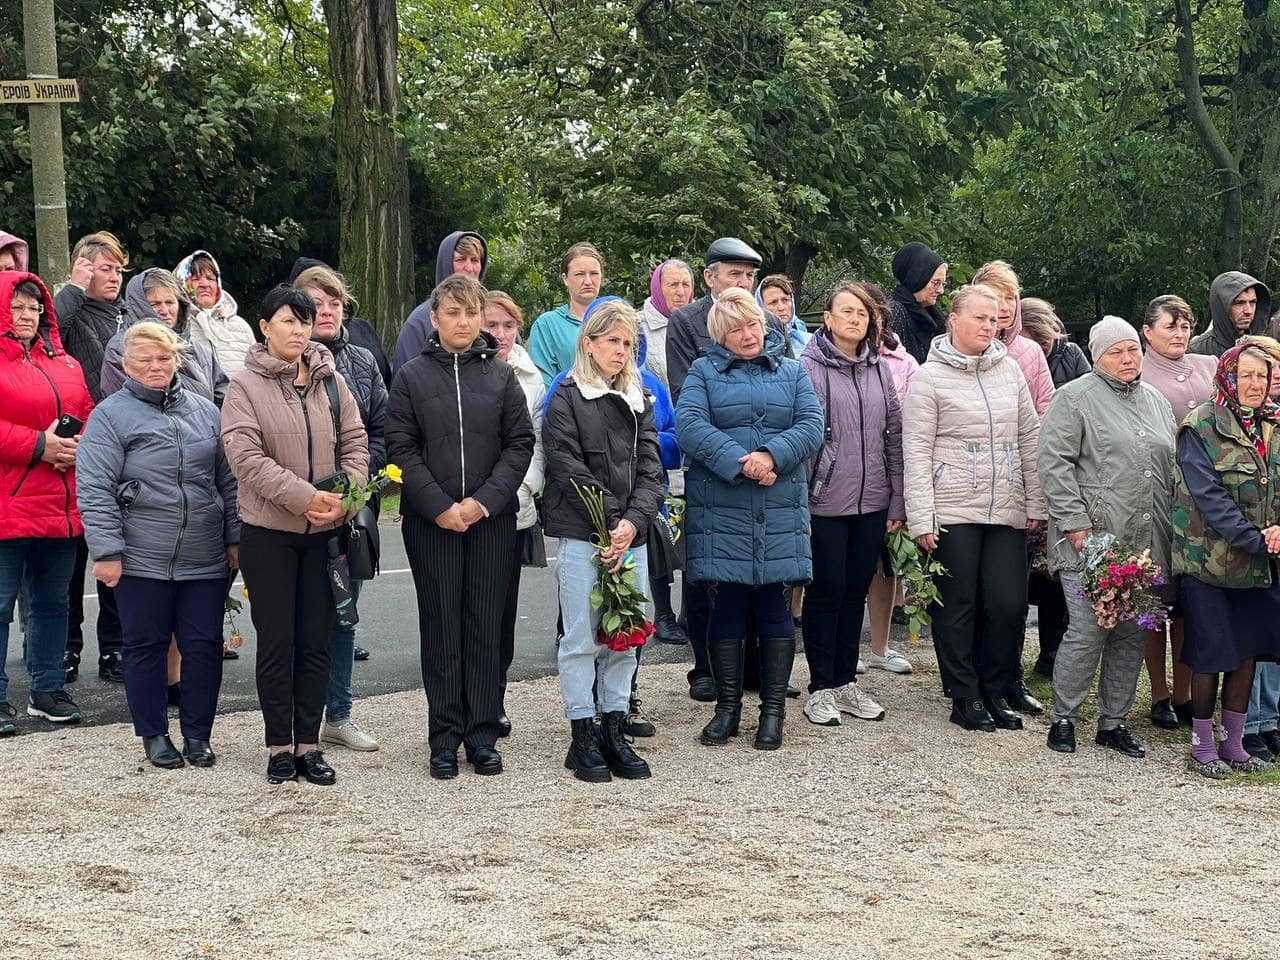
[0,648,1280,960]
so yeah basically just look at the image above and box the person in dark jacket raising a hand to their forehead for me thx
[54,230,129,684]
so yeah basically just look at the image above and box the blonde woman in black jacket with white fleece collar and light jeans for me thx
[543,300,664,783]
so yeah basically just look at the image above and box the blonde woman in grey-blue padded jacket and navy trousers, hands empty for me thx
[76,323,239,769]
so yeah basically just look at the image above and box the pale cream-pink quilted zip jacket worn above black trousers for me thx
[902,335,1047,538]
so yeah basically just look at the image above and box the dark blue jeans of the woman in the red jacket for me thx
[0,538,76,700]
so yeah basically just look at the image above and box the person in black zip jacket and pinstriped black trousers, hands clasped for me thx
[387,275,534,780]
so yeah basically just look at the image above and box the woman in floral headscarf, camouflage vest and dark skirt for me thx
[1172,337,1280,780]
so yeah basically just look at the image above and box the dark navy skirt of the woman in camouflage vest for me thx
[1178,576,1280,673]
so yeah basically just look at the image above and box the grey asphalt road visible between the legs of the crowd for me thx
[5,524,692,733]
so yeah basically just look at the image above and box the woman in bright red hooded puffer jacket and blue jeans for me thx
[0,271,93,736]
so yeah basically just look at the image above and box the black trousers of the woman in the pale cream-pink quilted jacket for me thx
[933,524,1027,699]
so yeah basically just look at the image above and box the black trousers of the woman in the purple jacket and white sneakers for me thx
[804,511,888,692]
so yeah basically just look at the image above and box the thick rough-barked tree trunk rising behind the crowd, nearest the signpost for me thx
[324,0,415,346]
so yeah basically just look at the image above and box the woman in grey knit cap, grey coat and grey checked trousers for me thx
[1039,316,1174,758]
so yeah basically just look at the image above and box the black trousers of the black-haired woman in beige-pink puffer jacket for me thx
[238,524,335,746]
